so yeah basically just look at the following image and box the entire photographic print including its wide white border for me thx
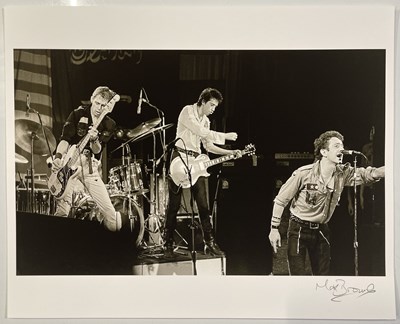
[5,6,395,319]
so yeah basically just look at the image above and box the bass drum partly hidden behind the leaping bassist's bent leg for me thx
[74,195,144,246]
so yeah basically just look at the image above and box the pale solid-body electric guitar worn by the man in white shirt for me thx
[170,144,256,188]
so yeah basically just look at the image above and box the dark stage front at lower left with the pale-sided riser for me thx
[17,212,226,275]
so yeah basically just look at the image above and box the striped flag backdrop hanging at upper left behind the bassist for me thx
[14,49,53,130]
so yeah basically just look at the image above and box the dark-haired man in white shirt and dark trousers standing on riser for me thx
[164,88,242,258]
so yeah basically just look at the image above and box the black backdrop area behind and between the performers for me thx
[16,50,385,275]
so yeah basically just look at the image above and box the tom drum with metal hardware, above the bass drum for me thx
[109,162,148,194]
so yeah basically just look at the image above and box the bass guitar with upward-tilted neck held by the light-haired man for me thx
[47,94,120,199]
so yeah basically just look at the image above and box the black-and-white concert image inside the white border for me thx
[14,49,385,276]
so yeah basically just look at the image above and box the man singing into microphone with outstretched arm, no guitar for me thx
[269,131,385,275]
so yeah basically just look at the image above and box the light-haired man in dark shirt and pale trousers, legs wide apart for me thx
[52,86,121,231]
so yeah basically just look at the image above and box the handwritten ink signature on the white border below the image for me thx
[315,279,376,302]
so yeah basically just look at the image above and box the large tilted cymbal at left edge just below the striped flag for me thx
[15,119,56,155]
